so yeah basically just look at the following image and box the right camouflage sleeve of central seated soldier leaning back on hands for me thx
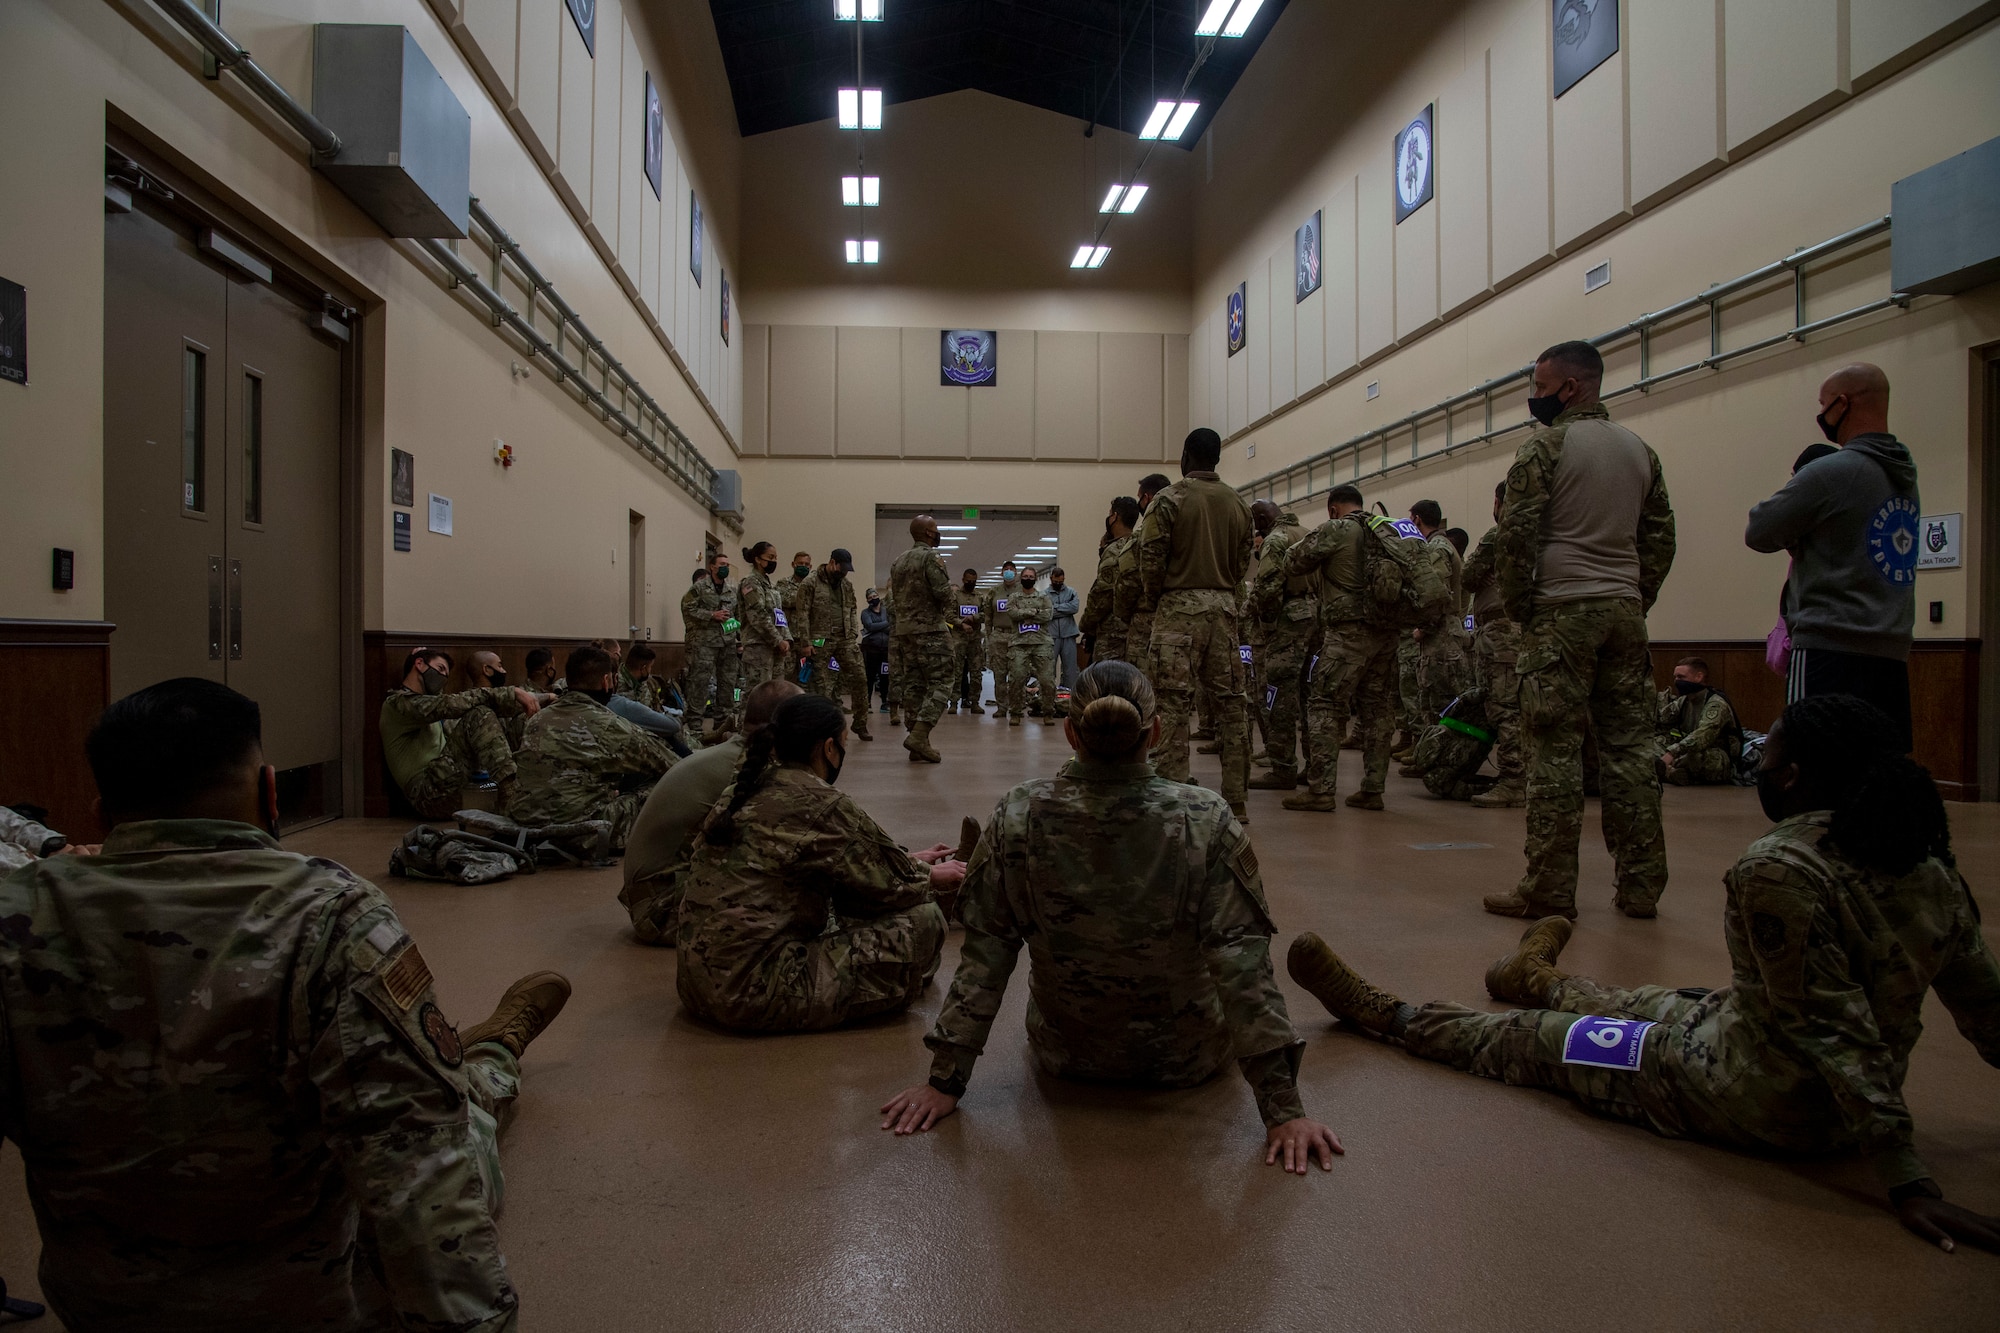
[1198,819,1306,1129]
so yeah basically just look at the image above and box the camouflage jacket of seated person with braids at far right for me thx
[1712,811,2000,1187]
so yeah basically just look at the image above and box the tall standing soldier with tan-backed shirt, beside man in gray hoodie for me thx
[1486,342,1674,919]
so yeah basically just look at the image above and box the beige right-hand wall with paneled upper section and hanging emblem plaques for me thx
[1188,0,2000,638]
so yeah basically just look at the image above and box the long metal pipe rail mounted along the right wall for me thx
[1236,216,1912,504]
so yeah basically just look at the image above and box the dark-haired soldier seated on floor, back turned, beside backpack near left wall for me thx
[506,648,674,851]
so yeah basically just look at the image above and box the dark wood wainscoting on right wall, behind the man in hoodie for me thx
[1652,638,1980,801]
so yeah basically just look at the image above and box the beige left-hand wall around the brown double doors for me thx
[0,0,732,638]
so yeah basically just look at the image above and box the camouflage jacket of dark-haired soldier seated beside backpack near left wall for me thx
[508,691,674,825]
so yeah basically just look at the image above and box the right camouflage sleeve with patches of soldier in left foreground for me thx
[308,891,518,1331]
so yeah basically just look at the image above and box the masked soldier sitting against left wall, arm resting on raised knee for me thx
[378,648,540,819]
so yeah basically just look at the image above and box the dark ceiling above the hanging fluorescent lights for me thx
[708,0,1286,148]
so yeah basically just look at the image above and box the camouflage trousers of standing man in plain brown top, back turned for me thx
[1148,588,1250,805]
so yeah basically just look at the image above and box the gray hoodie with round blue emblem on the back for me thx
[1744,434,1924,660]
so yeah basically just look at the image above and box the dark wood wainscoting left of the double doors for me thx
[0,620,116,843]
